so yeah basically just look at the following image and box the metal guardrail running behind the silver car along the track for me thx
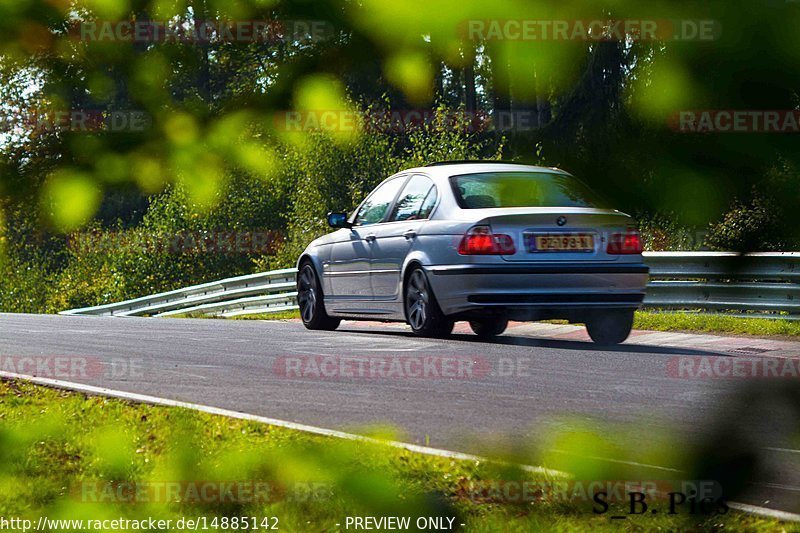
[61,252,800,318]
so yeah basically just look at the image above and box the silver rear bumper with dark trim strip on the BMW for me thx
[426,263,648,315]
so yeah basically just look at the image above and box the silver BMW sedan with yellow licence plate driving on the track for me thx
[297,162,648,344]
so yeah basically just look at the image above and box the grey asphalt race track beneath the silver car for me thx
[0,314,800,513]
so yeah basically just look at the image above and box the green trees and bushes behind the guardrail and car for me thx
[0,0,800,309]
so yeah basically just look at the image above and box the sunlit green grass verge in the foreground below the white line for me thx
[0,381,796,531]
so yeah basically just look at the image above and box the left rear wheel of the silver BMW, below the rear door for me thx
[403,267,455,337]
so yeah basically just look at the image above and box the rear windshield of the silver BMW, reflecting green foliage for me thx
[450,172,606,209]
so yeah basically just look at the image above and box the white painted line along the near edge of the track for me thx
[0,370,800,522]
